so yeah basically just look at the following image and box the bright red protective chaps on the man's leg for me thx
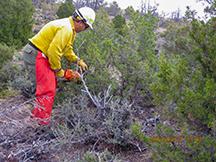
[32,52,56,125]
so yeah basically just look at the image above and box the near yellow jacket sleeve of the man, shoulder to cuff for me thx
[47,28,70,77]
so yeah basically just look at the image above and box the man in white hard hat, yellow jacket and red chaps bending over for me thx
[23,7,95,125]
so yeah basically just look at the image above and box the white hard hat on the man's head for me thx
[75,7,95,29]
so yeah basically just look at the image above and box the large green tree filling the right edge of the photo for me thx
[143,1,216,161]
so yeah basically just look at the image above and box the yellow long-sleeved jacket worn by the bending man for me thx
[29,17,78,77]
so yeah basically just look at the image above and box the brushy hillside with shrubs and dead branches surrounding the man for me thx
[0,0,216,162]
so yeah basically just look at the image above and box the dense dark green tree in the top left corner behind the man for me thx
[0,0,34,47]
